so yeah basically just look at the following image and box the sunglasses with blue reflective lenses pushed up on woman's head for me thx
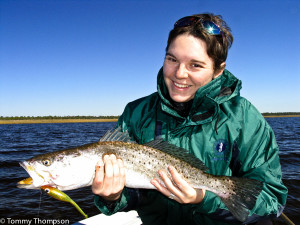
[174,16,223,35]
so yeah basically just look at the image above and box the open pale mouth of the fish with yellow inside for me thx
[17,161,45,189]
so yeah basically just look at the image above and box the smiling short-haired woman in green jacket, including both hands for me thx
[92,14,287,225]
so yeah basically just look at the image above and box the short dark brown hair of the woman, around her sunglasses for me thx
[166,13,233,71]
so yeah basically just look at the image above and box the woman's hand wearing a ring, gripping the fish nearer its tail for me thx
[151,166,206,204]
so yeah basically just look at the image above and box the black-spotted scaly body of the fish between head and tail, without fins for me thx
[81,141,234,198]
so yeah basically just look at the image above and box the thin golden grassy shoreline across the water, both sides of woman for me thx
[0,115,300,124]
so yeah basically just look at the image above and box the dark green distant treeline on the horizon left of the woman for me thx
[0,116,119,120]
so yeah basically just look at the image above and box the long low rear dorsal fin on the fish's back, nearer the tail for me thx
[143,139,208,171]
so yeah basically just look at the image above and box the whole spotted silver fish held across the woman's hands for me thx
[17,127,263,222]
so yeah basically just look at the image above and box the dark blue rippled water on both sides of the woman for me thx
[0,117,300,224]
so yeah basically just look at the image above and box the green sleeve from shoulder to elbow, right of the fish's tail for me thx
[237,104,288,223]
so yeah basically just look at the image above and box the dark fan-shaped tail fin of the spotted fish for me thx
[220,177,263,222]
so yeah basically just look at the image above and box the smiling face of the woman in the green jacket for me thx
[163,34,223,102]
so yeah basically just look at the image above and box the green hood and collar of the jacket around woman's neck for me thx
[157,68,242,123]
